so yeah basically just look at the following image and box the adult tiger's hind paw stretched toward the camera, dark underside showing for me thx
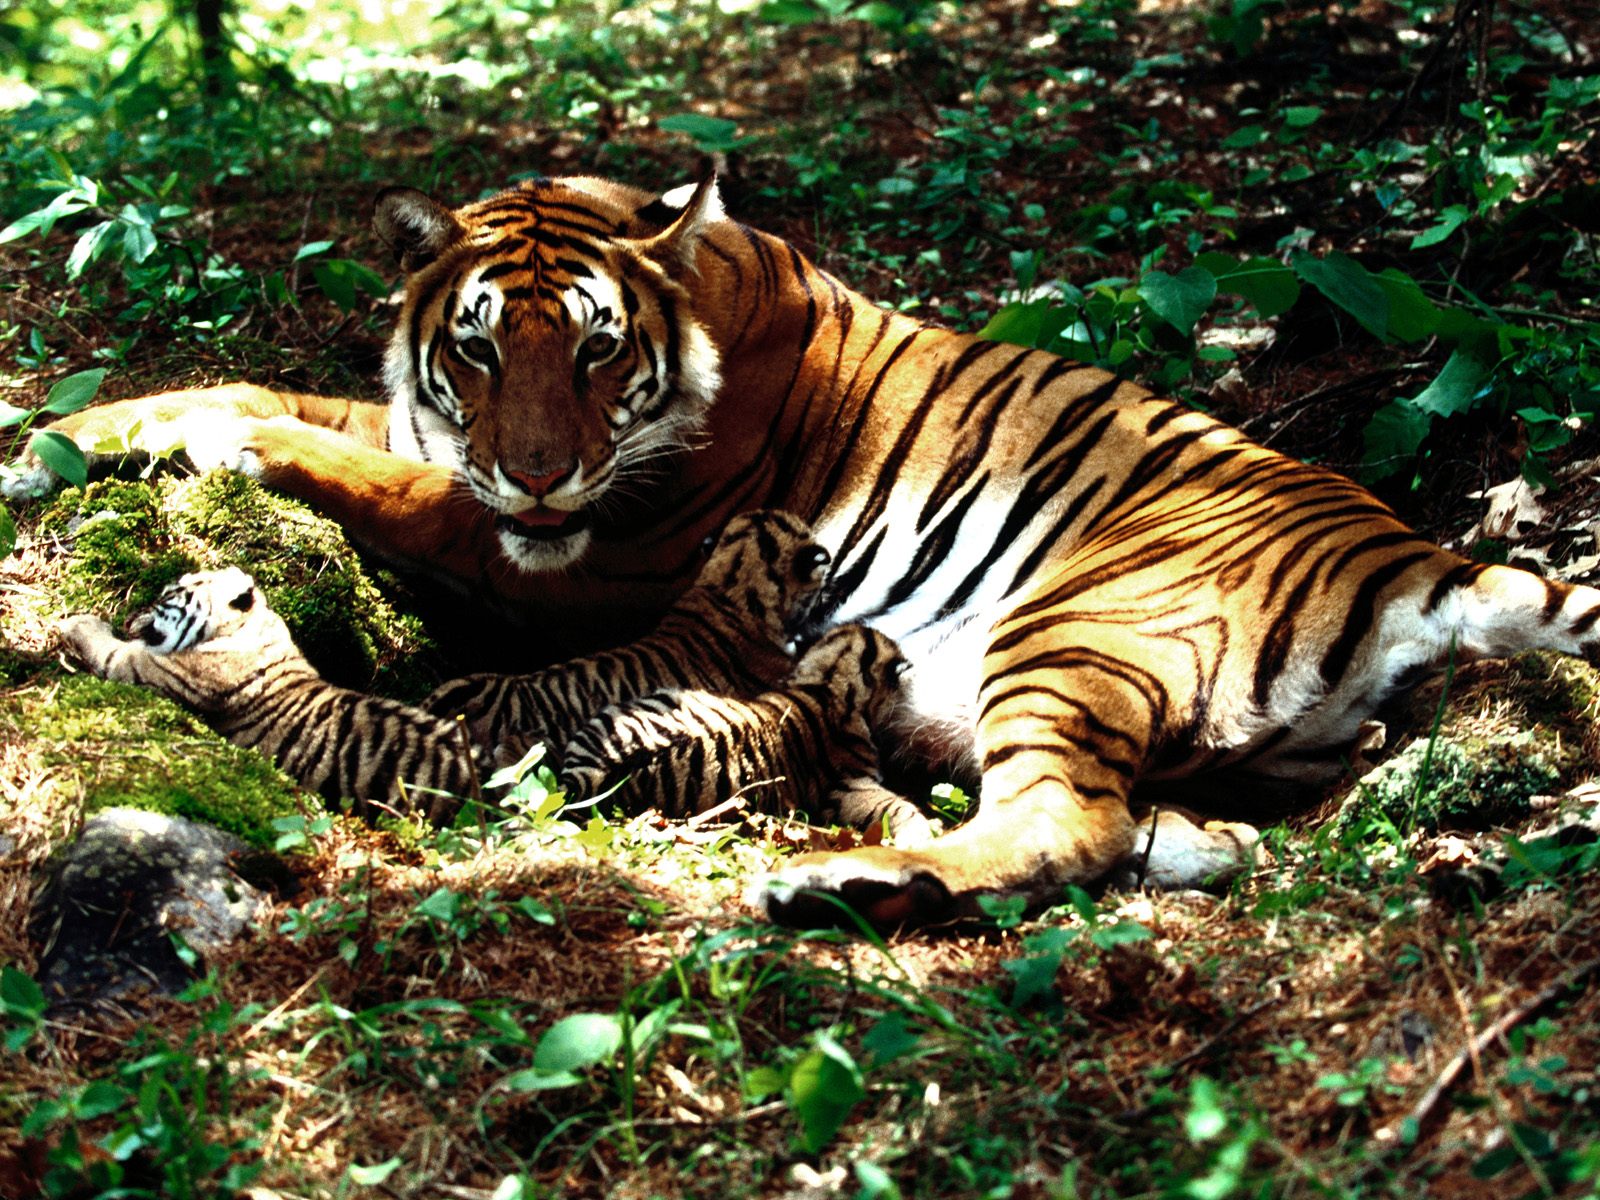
[746,846,960,933]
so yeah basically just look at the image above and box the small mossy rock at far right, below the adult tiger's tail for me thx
[1333,731,1560,832]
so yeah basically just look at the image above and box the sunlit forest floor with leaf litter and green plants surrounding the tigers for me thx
[0,0,1600,1200]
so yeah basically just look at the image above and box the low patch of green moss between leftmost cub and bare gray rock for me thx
[9,675,309,846]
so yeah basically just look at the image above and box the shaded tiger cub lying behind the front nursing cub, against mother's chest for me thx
[422,510,829,762]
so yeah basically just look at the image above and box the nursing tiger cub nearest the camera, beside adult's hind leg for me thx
[562,626,933,843]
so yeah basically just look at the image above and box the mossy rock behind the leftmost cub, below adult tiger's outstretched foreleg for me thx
[40,470,438,699]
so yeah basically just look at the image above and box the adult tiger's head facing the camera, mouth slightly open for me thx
[374,178,723,571]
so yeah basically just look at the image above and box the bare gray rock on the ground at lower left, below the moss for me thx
[27,808,266,1010]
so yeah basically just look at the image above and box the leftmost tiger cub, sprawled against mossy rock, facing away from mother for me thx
[56,566,477,822]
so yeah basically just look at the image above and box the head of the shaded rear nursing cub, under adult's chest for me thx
[694,509,830,645]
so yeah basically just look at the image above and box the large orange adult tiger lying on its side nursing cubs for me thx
[18,178,1600,923]
